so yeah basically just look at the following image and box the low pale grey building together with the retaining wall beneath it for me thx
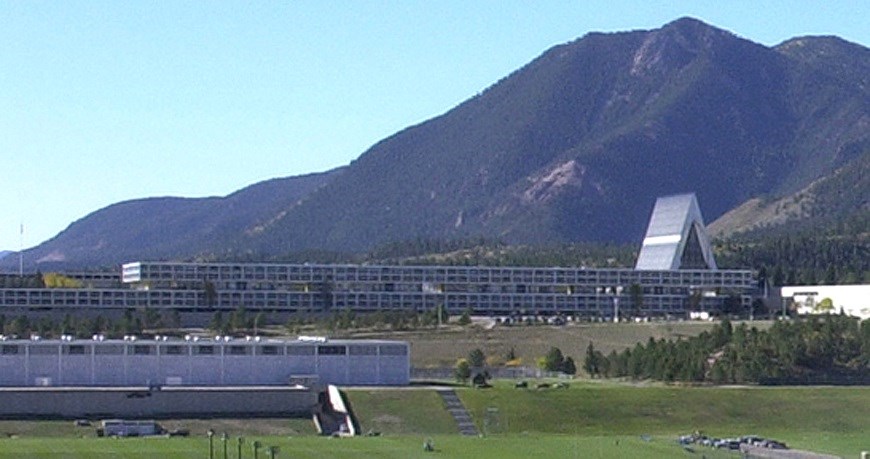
[0,336,411,418]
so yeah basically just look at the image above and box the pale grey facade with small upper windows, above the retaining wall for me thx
[0,337,410,387]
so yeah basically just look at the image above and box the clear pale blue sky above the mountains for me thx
[0,0,870,250]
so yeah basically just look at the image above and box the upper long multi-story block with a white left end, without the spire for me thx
[110,262,755,318]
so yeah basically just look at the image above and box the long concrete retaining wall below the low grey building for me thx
[0,387,317,419]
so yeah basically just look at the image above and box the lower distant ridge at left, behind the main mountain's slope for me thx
[8,168,343,271]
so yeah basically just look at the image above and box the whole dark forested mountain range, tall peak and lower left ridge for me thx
[8,18,870,265]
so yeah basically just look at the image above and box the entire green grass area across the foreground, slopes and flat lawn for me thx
[0,382,870,459]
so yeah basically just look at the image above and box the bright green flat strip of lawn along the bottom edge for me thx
[0,434,735,459]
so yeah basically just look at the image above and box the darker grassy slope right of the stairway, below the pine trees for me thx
[459,382,870,457]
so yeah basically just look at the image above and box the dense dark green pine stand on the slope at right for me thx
[584,315,870,384]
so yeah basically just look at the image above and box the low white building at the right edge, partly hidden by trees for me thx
[780,284,870,320]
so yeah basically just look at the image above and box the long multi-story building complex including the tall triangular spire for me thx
[0,195,755,320]
